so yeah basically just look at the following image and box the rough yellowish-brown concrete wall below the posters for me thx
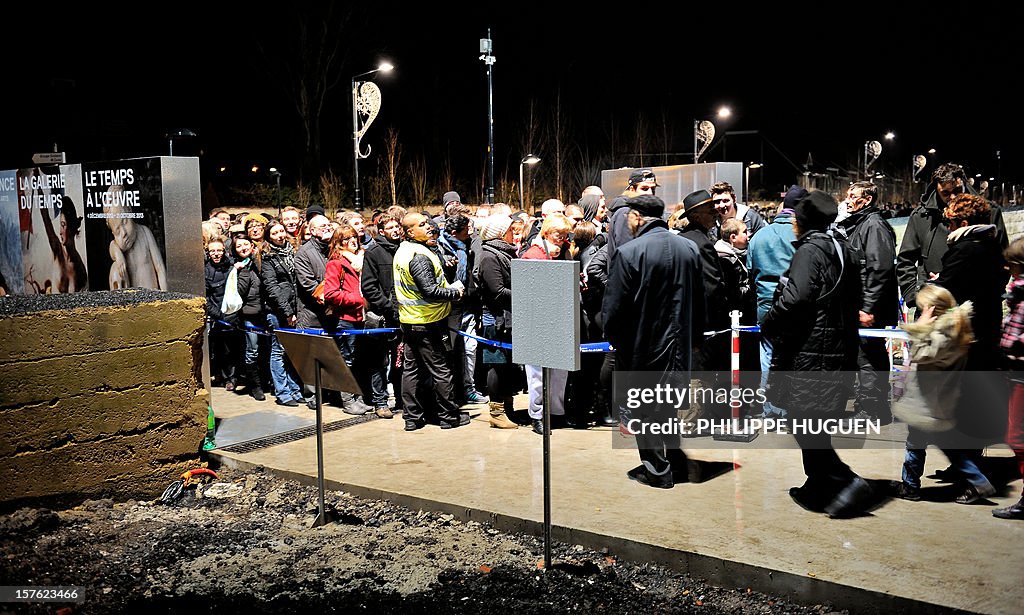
[0,290,209,507]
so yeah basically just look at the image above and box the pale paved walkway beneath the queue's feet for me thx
[207,389,1024,614]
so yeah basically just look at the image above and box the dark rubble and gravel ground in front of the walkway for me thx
[0,469,847,615]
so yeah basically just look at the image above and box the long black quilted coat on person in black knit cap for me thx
[761,231,861,414]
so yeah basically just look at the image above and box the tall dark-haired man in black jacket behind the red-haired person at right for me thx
[896,163,1008,308]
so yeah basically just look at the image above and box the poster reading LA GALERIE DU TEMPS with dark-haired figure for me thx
[16,165,90,295]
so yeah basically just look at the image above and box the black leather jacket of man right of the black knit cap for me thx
[839,206,899,326]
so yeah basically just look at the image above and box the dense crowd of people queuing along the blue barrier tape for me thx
[203,164,1024,519]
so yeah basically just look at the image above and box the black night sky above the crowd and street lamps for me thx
[0,2,1024,199]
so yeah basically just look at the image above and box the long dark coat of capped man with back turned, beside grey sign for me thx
[602,220,705,372]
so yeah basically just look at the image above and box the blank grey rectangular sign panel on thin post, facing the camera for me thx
[512,259,580,371]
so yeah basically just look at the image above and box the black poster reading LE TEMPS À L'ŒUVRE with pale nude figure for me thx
[82,158,167,291]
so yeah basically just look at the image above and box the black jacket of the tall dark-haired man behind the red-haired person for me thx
[896,180,1009,307]
